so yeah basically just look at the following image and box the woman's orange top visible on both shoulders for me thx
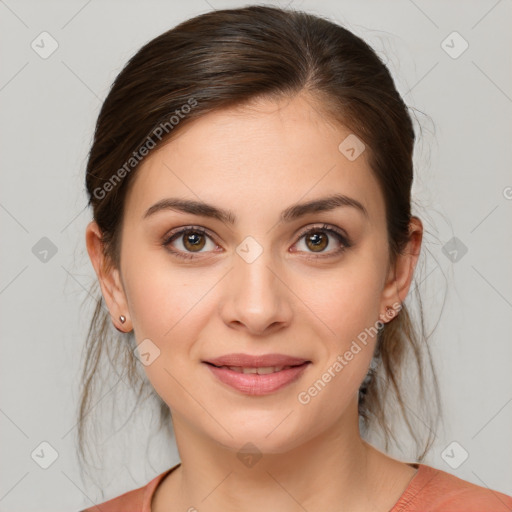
[81,463,512,512]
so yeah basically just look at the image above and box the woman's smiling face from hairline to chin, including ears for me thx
[87,91,418,453]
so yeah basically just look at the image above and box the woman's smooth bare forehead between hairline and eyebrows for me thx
[126,96,384,226]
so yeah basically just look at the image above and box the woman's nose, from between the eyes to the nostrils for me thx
[221,251,293,336]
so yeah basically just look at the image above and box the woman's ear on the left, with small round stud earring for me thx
[85,221,132,332]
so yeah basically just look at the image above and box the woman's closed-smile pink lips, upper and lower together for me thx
[203,354,311,395]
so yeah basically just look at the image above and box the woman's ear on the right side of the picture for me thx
[380,216,423,323]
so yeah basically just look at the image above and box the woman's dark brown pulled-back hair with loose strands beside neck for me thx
[78,5,439,482]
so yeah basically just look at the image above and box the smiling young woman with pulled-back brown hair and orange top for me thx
[80,6,512,512]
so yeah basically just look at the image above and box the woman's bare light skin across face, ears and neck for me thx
[86,94,423,512]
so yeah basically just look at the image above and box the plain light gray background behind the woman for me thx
[0,0,512,512]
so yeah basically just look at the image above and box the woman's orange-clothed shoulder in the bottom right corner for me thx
[390,464,512,512]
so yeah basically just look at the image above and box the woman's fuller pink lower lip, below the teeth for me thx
[204,363,309,395]
